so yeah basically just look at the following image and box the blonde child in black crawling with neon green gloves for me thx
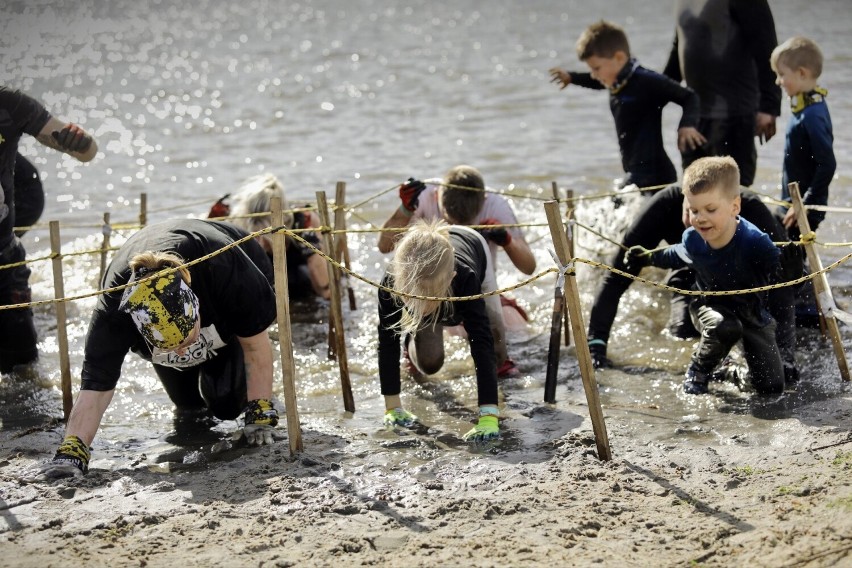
[378,220,506,442]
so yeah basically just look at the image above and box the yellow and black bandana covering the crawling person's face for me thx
[119,269,198,350]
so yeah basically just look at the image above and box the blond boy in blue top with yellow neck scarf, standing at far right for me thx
[769,37,837,235]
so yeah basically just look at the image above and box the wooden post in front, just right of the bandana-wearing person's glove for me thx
[270,197,304,455]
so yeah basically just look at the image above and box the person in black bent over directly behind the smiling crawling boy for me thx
[588,184,802,384]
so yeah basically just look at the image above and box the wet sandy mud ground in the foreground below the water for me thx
[0,374,852,567]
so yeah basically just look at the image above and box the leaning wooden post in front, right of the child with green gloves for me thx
[544,201,612,461]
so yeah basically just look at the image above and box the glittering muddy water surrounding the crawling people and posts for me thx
[0,0,852,467]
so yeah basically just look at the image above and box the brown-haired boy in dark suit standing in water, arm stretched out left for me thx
[550,20,706,187]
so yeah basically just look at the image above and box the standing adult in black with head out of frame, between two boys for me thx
[664,0,781,187]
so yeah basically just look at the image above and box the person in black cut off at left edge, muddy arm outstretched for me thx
[0,86,98,373]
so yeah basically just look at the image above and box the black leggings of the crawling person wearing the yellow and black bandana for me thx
[154,341,248,420]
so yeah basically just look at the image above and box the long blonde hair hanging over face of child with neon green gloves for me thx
[389,219,456,334]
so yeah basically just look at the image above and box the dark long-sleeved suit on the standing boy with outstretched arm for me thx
[571,60,698,187]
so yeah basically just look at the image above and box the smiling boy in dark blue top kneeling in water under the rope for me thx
[627,156,784,394]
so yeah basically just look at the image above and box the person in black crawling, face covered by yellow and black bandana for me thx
[37,219,278,479]
